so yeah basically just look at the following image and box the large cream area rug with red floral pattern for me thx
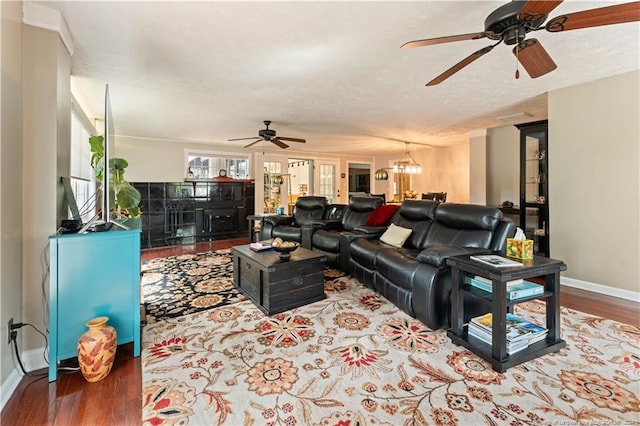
[142,260,640,426]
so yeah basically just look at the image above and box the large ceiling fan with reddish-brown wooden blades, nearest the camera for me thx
[400,0,640,86]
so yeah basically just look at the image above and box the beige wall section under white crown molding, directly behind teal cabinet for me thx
[21,25,71,350]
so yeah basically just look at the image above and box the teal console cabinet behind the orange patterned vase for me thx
[49,228,140,382]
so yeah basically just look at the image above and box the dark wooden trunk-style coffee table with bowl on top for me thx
[231,244,327,315]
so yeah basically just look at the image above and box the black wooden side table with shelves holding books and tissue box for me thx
[447,255,567,372]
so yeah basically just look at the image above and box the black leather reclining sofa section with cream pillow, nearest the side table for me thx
[348,200,515,329]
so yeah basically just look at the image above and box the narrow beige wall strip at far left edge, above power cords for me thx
[0,1,23,398]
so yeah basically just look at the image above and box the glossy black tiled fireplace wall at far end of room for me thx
[133,178,255,248]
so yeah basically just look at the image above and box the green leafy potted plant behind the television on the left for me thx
[89,136,142,219]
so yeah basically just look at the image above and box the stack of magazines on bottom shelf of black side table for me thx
[469,313,549,355]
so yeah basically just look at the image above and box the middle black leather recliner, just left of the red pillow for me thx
[311,196,383,271]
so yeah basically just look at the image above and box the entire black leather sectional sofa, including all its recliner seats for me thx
[261,197,515,330]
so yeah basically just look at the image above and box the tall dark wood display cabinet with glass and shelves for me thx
[516,120,550,257]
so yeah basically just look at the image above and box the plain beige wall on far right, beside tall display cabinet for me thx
[549,71,640,292]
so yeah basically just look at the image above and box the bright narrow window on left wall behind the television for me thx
[69,103,97,222]
